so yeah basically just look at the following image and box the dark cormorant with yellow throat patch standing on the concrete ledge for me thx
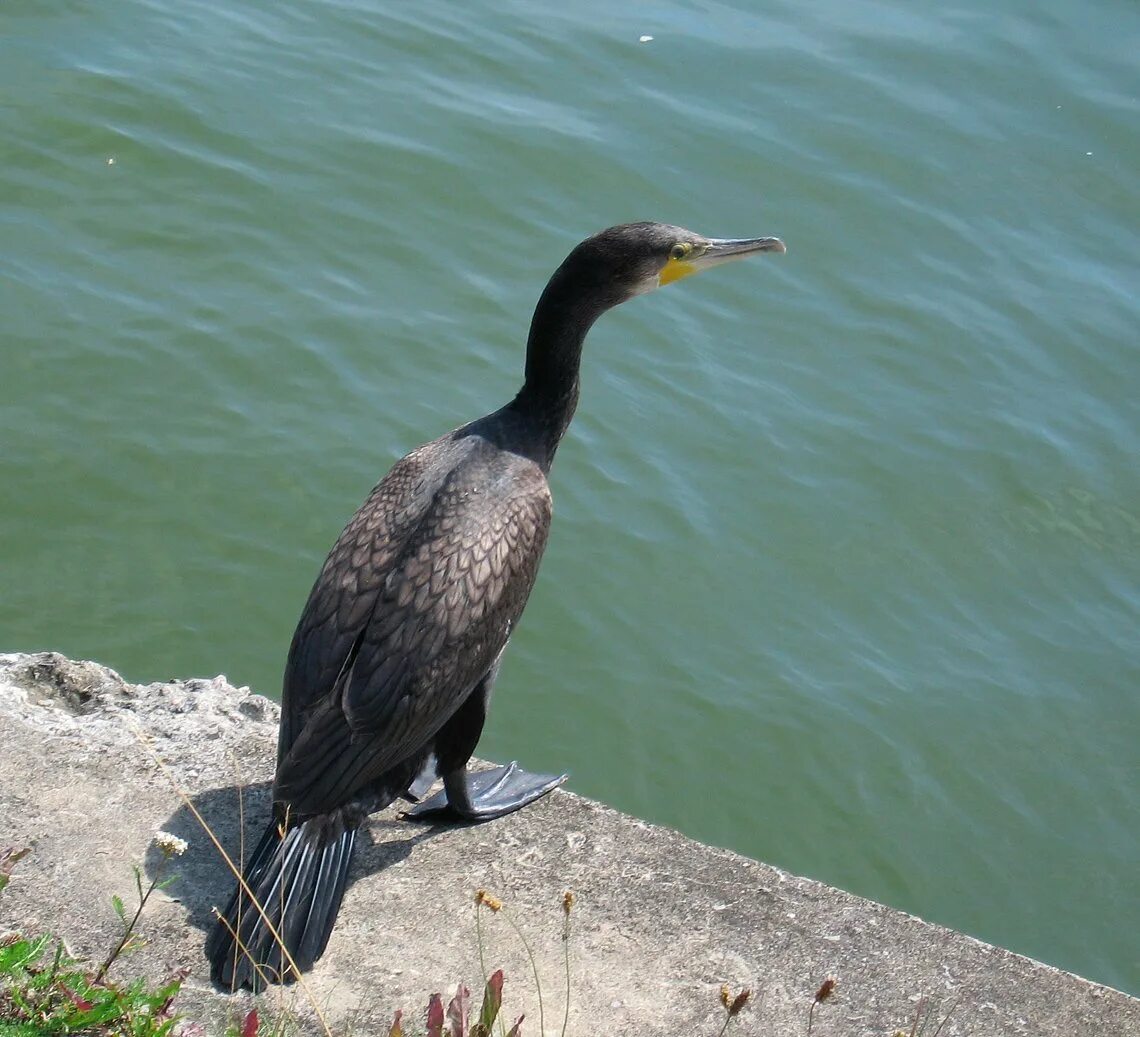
[206,223,784,989]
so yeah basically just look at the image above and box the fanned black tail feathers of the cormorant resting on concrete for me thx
[206,810,358,993]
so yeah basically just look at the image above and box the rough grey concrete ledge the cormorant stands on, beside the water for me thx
[0,653,1140,1037]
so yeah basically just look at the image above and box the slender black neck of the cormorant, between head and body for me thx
[511,270,613,468]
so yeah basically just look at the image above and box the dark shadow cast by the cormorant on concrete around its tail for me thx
[144,782,455,957]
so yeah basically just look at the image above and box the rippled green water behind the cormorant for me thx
[0,0,1140,993]
